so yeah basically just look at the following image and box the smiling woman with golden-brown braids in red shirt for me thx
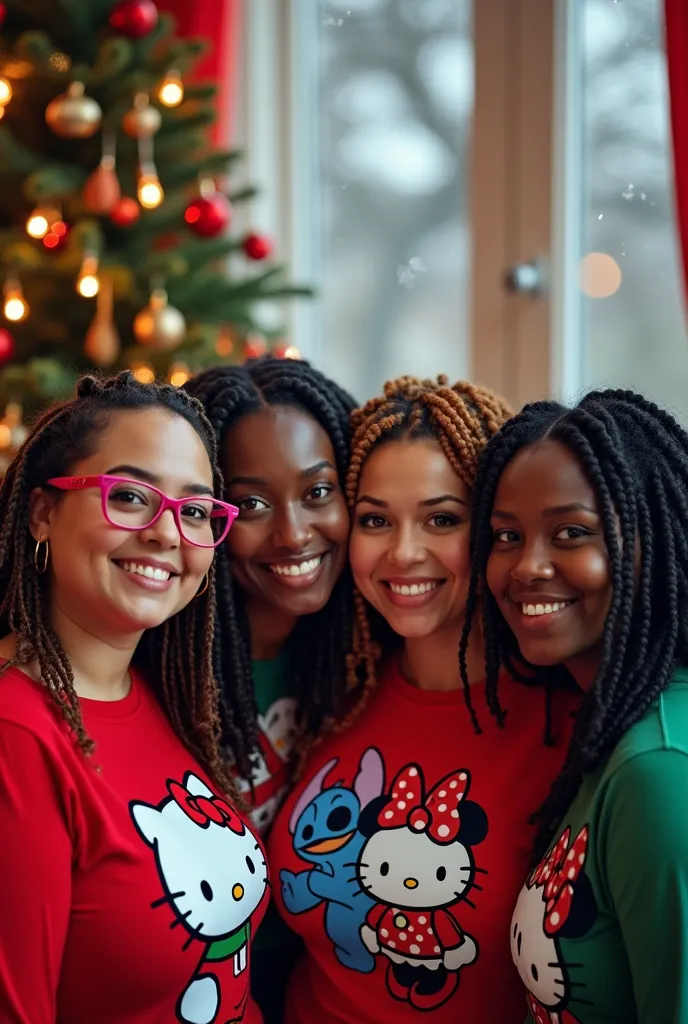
[269,378,572,1024]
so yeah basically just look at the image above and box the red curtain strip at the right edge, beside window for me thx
[664,0,688,301]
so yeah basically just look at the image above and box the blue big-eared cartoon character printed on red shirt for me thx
[280,748,385,974]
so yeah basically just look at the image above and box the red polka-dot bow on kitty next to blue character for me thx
[378,765,469,844]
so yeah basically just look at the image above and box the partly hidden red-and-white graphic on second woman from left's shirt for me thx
[237,697,297,835]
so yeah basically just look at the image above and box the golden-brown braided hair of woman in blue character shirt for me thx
[338,376,511,728]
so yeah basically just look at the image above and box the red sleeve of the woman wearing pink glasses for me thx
[0,722,72,1024]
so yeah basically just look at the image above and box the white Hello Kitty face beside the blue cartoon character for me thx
[359,828,473,910]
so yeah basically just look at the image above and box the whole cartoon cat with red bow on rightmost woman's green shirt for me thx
[511,825,598,1024]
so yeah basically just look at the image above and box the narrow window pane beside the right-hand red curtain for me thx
[568,0,688,419]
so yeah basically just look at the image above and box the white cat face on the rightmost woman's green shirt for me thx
[511,885,566,1010]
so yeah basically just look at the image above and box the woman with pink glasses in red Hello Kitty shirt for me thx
[0,373,268,1024]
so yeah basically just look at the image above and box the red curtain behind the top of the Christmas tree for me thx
[158,0,242,145]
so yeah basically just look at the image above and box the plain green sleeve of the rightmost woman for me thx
[599,751,688,1024]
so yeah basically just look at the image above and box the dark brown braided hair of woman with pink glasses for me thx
[0,371,239,800]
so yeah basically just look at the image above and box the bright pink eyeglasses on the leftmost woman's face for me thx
[47,474,239,548]
